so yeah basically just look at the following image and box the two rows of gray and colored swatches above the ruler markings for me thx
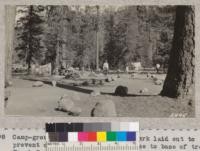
[46,122,139,142]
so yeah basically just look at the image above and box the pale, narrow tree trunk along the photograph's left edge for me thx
[5,6,16,84]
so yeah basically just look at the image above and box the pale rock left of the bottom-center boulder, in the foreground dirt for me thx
[58,95,74,112]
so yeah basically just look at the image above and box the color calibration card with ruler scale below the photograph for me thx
[46,122,139,151]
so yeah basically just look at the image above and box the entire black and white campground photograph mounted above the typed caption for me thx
[4,5,195,118]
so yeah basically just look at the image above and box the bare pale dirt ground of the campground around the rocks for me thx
[5,74,194,117]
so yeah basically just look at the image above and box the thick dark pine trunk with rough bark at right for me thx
[161,6,195,99]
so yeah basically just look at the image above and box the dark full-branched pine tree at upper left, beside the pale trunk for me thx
[16,5,44,73]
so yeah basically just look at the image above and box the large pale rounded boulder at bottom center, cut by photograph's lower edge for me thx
[91,100,117,117]
